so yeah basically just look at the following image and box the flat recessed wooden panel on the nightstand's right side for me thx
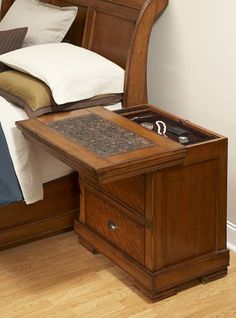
[163,160,219,265]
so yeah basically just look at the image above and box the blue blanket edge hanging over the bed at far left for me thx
[0,123,23,205]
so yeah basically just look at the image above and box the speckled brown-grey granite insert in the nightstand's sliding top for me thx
[48,114,154,157]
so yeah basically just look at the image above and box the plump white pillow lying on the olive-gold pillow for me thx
[0,43,124,105]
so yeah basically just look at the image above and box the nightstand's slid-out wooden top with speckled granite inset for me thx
[17,107,186,183]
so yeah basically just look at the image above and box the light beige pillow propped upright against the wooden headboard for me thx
[0,0,78,47]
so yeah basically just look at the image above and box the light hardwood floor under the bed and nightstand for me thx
[0,232,236,318]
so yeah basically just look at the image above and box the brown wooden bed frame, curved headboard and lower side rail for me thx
[0,0,168,249]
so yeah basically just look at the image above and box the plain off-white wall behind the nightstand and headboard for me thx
[148,0,236,247]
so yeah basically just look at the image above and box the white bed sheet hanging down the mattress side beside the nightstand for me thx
[0,97,121,204]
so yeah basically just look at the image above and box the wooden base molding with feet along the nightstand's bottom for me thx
[75,221,229,301]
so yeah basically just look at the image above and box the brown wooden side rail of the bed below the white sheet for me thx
[0,174,79,249]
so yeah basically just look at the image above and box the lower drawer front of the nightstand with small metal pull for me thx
[85,191,145,264]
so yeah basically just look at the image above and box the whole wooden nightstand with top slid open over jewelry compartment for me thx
[17,105,229,300]
